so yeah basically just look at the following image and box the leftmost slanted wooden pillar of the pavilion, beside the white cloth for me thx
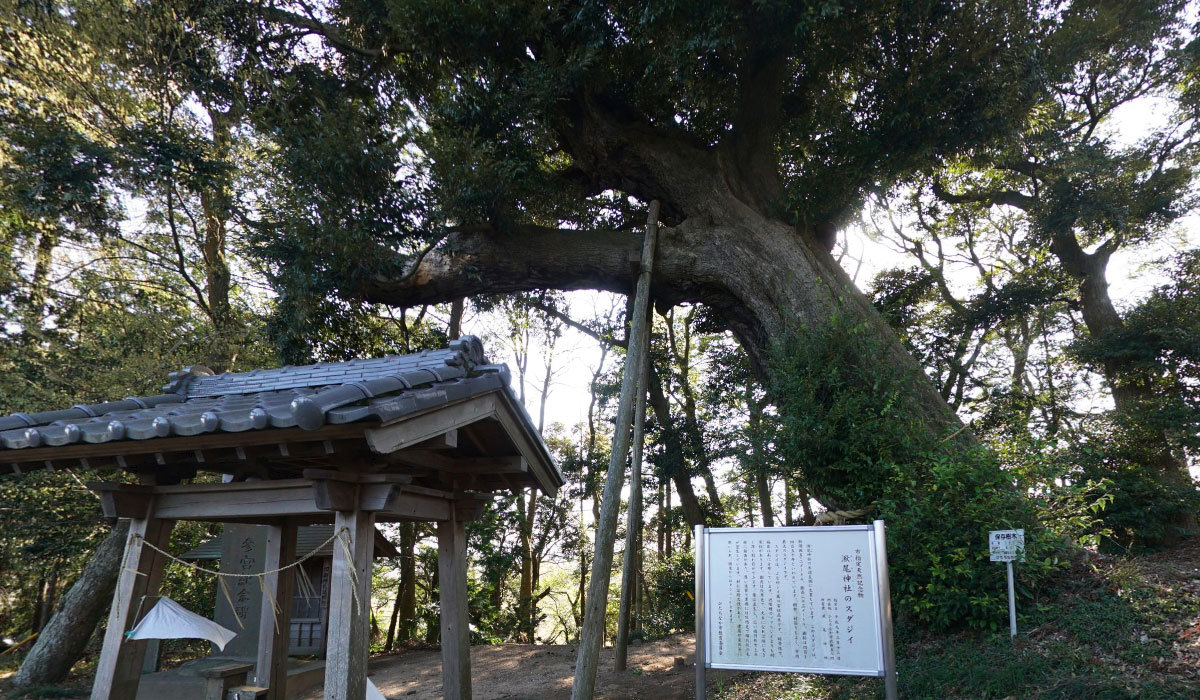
[91,511,175,700]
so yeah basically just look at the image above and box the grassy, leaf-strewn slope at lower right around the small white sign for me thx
[713,544,1200,700]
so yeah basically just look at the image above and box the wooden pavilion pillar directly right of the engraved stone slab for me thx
[253,523,295,700]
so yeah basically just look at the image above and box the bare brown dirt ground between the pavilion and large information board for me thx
[301,634,729,700]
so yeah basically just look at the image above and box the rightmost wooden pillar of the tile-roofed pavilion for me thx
[438,508,470,700]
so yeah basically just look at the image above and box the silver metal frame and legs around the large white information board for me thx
[694,520,899,700]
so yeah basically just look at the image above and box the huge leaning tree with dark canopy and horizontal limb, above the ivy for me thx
[233,0,1056,430]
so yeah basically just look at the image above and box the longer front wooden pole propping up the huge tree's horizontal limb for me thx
[571,201,659,700]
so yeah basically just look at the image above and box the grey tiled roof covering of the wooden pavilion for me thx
[0,336,509,450]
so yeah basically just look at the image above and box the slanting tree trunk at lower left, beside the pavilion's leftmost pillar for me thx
[12,520,130,688]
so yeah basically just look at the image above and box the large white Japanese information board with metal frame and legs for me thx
[696,520,898,700]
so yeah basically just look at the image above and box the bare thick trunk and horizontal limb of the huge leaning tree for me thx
[360,207,961,444]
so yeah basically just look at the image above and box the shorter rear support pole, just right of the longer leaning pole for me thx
[613,302,653,671]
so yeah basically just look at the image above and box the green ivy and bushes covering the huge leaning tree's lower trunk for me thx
[774,318,1058,628]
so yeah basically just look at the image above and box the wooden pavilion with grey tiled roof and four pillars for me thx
[0,336,563,700]
